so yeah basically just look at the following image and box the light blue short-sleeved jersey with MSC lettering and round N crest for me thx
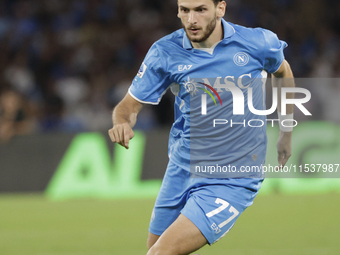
[129,19,287,178]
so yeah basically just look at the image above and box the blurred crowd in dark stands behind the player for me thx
[0,0,340,141]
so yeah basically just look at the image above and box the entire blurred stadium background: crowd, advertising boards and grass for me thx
[0,0,340,255]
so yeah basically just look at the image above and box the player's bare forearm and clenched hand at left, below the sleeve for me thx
[109,93,143,149]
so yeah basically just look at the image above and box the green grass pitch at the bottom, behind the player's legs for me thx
[0,194,340,255]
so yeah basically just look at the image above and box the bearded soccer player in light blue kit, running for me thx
[109,0,294,255]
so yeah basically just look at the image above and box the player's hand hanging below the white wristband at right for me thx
[276,131,292,167]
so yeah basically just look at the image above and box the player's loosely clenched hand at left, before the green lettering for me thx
[109,123,135,149]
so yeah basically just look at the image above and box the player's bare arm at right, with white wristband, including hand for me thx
[272,60,295,166]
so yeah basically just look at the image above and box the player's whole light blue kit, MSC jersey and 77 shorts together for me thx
[129,19,286,244]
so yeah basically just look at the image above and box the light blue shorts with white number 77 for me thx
[149,162,263,245]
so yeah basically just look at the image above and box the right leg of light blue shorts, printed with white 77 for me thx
[181,185,256,245]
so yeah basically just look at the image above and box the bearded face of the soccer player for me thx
[177,0,223,43]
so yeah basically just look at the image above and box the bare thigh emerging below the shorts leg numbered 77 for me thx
[147,214,207,255]
